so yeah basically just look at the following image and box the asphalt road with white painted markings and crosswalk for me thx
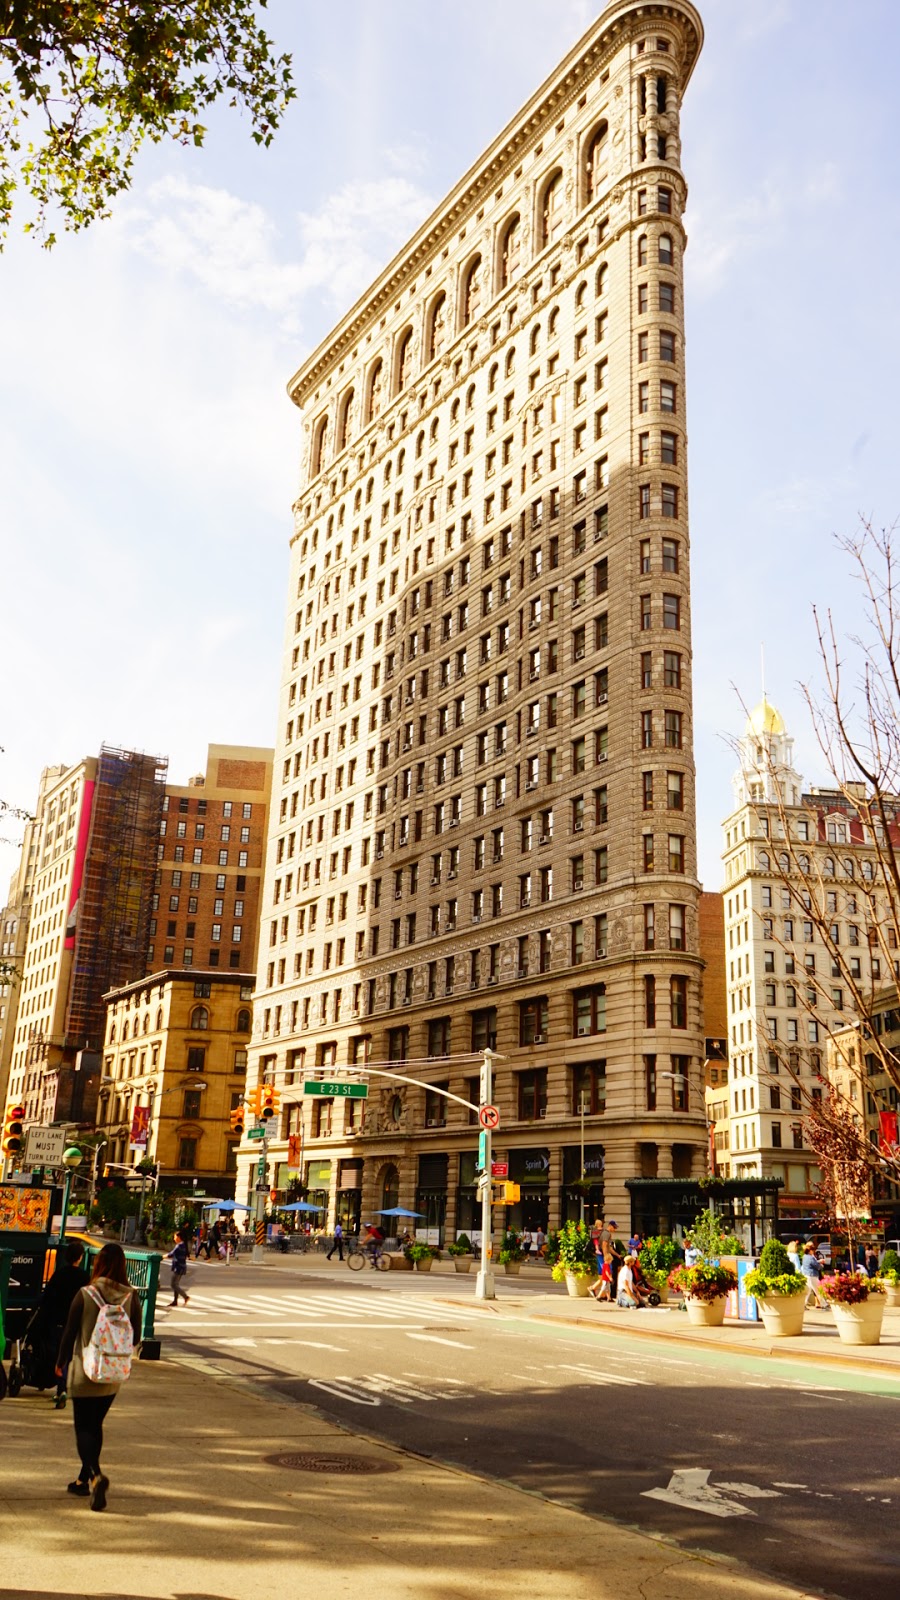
[159,1262,900,1600]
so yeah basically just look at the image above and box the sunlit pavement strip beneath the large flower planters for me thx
[483,1294,900,1382]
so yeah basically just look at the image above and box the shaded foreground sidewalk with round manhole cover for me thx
[0,1360,809,1600]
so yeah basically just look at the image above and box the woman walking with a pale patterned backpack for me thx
[56,1245,141,1510]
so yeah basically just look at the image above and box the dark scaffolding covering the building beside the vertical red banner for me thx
[66,744,168,1050]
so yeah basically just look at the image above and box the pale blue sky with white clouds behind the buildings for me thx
[0,0,900,898]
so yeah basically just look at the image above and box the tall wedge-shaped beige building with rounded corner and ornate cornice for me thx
[239,0,706,1238]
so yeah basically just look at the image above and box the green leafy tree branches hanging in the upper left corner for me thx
[0,0,295,246]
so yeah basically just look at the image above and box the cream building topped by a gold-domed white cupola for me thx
[722,696,897,1219]
